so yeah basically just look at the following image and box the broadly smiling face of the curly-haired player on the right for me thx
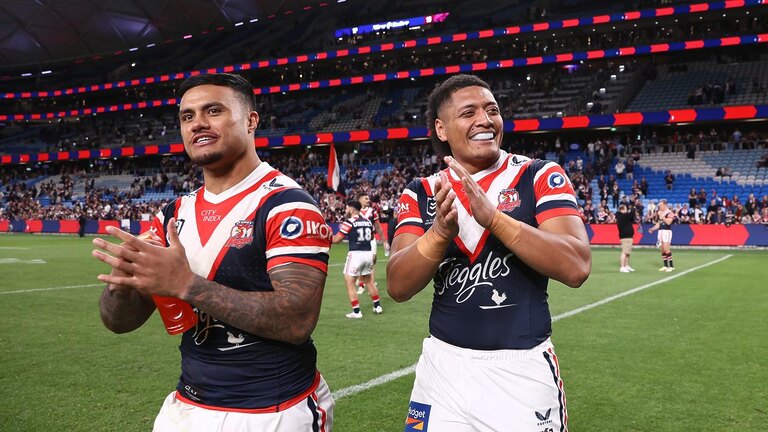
[435,86,504,173]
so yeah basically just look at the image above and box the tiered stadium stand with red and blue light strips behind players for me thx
[0,0,768,233]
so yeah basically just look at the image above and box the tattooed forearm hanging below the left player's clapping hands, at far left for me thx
[99,285,155,333]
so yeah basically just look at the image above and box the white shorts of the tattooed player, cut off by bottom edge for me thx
[152,374,334,432]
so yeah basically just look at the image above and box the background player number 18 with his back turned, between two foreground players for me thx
[333,200,384,319]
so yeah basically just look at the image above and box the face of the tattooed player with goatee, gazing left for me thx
[179,84,259,169]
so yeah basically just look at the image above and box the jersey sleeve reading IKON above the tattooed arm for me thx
[264,189,333,273]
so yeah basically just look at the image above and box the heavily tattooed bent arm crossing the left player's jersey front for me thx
[187,264,326,344]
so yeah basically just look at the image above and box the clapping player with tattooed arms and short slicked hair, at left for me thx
[94,74,333,432]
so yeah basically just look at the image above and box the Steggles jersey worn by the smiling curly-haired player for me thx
[395,151,579,350]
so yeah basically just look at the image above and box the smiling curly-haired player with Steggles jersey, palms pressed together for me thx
[387,75,591,432]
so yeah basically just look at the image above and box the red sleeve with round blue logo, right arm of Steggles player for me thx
[531,161,579,224]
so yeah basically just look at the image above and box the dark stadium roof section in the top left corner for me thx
[0,0,328,68]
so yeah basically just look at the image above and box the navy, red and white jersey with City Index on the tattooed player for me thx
[148,162,332,409]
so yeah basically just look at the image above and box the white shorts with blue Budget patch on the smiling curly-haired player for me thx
[405,337,568,432]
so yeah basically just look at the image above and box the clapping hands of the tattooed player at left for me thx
[92,218,195,298]
